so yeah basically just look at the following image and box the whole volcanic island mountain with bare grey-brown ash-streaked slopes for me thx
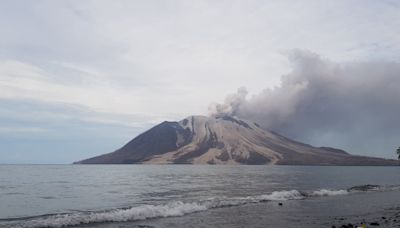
[75,116,398,165]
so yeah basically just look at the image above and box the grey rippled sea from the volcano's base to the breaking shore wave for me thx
[0,165,400,227]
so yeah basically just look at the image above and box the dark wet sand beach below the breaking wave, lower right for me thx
[90,191,400,228]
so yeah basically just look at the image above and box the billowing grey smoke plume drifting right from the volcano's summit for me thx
[210,50,400,158]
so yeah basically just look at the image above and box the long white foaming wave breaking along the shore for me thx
[0,185,393,228]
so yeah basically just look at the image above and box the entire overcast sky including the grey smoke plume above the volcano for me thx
[0,0,400,163]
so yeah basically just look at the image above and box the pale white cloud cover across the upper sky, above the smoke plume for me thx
[0,0,400,162]
